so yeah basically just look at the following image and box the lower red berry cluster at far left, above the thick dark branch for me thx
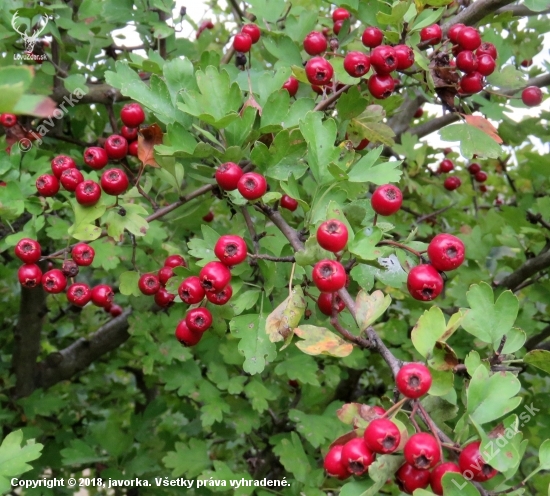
[15,238,122,317]
